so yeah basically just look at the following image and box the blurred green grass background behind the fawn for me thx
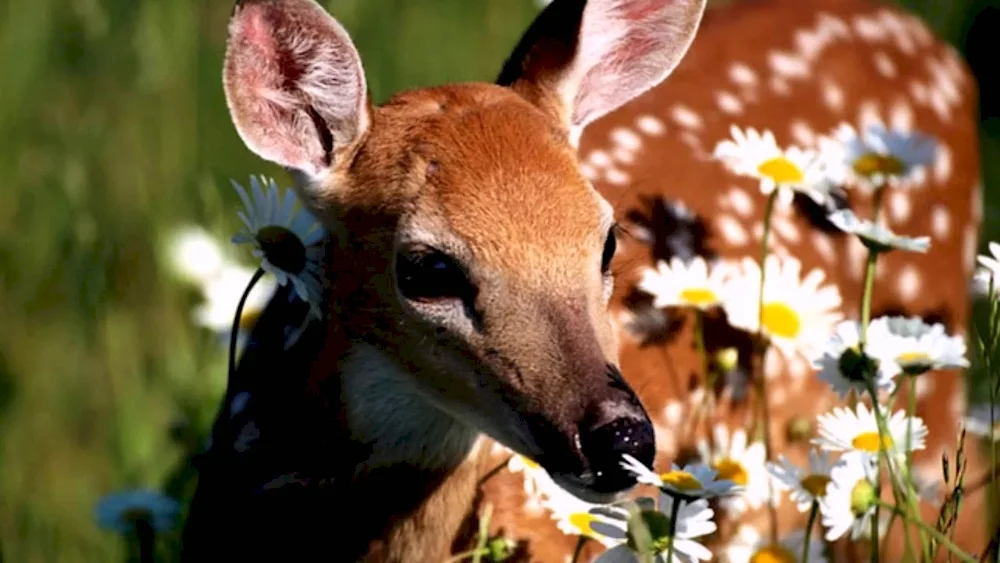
[0,0,1000,563]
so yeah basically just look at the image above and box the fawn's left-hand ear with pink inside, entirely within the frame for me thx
[223,0,371,179]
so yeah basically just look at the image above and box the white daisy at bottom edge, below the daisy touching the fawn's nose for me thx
[595,493,716,563]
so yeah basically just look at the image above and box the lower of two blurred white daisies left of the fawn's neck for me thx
[194,264,277,341]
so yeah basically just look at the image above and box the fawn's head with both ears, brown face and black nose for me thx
[224,0,705,501]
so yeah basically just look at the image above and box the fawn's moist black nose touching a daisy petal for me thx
[580,401,656,494]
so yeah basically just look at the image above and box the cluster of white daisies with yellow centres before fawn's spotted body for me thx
[512,120,1000,562]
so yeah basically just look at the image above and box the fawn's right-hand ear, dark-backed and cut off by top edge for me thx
[497,0,706,141]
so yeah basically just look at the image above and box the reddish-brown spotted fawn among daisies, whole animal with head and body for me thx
[185,0,982,561]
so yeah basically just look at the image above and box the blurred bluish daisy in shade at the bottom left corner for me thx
[94,489,181,534]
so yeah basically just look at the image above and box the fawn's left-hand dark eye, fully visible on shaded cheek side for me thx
[396,249,475,302]
